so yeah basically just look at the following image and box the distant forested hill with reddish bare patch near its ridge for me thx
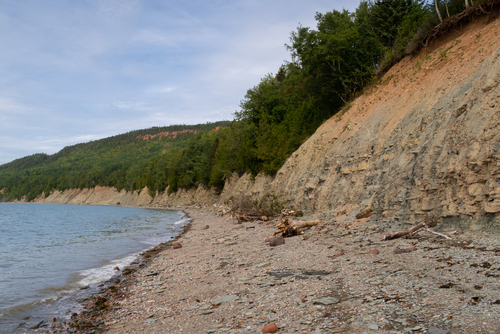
[0,121,230,200]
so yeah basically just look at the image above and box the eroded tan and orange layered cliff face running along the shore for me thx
[37,17,500,230]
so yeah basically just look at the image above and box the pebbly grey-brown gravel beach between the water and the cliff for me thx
[51,207,500,334]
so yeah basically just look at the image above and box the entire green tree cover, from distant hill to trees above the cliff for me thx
[0,0,484,200]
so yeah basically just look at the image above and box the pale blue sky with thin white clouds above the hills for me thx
[0,0,359,165]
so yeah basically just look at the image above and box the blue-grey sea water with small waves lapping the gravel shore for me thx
[0,203,189,333]
